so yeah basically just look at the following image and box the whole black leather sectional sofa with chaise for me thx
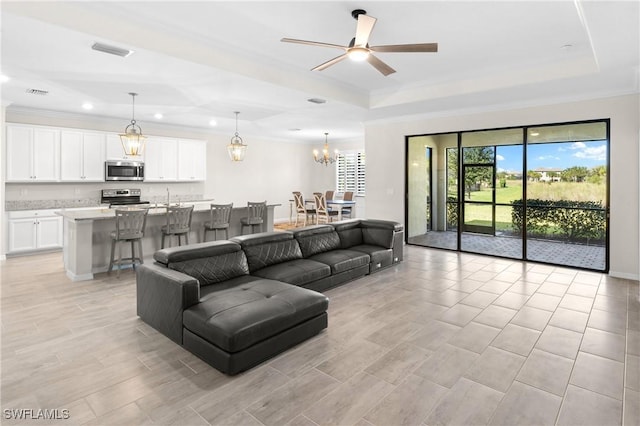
[136,219,404,374]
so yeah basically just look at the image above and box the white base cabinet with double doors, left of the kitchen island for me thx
[8,210,62,253]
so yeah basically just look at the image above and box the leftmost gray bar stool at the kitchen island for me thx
[107,209,148,278]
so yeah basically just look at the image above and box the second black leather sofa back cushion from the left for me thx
[231,231,302,272]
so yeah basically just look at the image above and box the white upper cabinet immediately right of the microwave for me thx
[144,137,178,182]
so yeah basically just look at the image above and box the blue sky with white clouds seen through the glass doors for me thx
[496,141,607,172]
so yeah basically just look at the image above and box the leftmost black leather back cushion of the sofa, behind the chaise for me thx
[153,241,249,286]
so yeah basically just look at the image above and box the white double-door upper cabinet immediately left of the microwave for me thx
[60,130,105,182]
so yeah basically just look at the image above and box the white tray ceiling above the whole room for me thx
[0,0,640,141]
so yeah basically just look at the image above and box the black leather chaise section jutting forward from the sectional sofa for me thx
[182,279,329,374]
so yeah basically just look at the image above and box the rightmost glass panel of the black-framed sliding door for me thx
[526,121,609,270]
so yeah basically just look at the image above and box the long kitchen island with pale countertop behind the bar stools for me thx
[56,201,280,281]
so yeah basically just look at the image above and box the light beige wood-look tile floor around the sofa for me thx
[1,246,640,426]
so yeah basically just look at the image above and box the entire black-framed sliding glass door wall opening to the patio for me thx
[405,120,609,271]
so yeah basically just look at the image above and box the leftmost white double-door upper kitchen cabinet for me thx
[7,125,60,182]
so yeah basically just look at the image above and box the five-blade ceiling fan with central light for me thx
[280,9,438,76]
